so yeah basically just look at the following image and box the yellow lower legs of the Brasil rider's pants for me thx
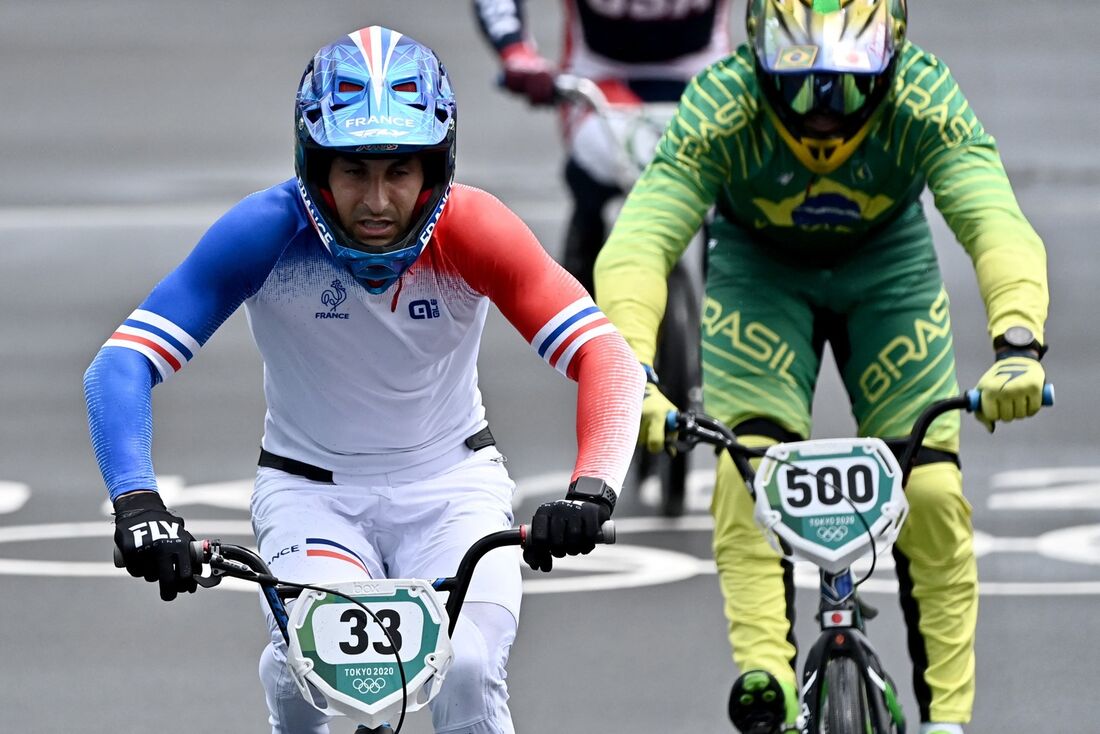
[711,436,978,723]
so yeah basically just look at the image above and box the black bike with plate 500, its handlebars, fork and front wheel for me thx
[668,384,1054,734]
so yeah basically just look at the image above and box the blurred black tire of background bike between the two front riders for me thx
[653,265,700,517]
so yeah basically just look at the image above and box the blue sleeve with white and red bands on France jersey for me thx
[84,182,304,500]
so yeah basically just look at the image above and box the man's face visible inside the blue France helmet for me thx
[329,155,424,247]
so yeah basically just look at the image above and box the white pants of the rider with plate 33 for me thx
[252,447,521,734]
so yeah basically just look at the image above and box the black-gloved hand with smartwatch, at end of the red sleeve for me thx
[524,476,615,571]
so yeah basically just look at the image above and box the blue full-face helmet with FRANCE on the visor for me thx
[294,25,457,293]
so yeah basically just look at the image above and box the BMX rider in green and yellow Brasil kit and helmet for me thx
[595,0,1048,734]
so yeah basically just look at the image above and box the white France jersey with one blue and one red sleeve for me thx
[86,179,644,499]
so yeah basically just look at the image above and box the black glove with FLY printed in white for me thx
[114,492,196,602]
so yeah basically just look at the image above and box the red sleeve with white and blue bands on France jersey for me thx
[438,186,645,491]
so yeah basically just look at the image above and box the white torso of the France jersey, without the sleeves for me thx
[244,238,488,474]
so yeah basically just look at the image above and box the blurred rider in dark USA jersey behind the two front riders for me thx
[474,0,730,293]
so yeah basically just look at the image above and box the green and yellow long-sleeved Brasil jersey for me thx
[595,42,1048,363]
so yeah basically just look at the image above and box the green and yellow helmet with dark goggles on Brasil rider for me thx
[745,0,906,174]
